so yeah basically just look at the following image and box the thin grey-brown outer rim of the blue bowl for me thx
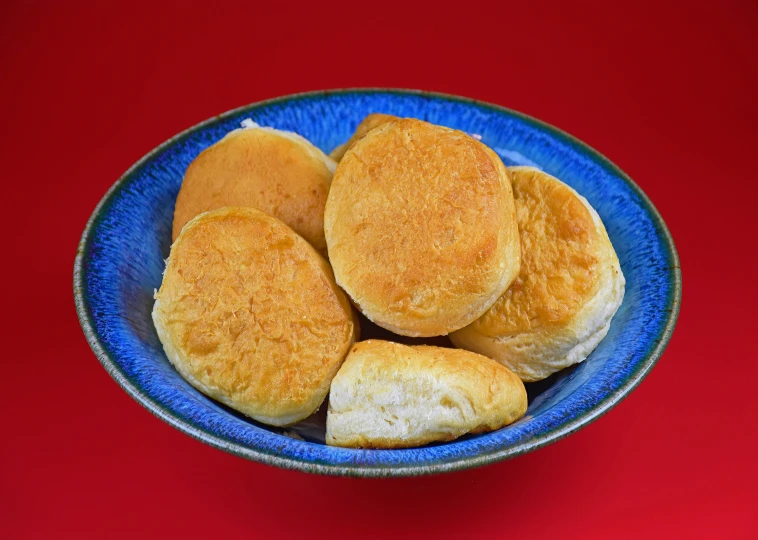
[73,87,682,477]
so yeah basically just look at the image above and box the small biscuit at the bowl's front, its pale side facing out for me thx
[326,340,527,448]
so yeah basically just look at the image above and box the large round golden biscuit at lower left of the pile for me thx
[153,207,358,426]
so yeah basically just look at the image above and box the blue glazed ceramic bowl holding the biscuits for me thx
[74,89,681,476]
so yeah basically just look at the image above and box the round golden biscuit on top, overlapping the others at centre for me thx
[324,118,520,337]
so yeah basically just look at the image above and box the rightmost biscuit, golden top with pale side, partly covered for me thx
[450,167,625,382]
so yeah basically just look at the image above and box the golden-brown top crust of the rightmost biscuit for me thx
[474,168,605,335]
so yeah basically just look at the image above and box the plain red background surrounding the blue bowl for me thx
[0,0,758,538]
